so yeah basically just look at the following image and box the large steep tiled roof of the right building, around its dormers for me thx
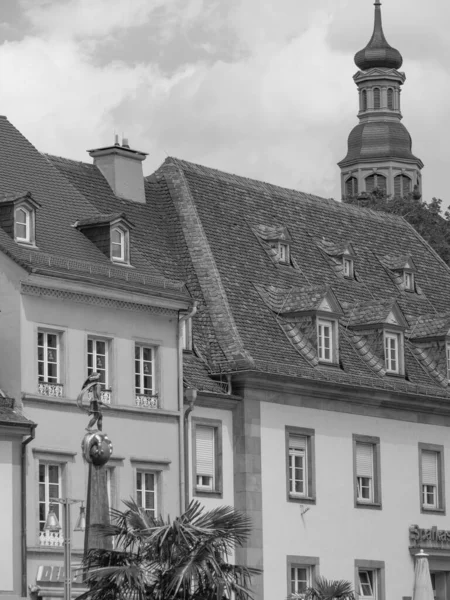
[150,158,450,396]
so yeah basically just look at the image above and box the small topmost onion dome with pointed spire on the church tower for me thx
[355,0,403,71]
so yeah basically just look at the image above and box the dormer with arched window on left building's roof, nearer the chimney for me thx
[74,213,134,265]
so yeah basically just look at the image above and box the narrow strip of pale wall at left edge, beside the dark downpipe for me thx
[0,439,13,593]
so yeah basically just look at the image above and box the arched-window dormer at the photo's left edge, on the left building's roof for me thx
[0,192,41,246]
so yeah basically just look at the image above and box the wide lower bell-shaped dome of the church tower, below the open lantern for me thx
[339,121,422,167]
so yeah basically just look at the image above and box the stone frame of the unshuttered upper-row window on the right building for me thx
[285,425,316,504]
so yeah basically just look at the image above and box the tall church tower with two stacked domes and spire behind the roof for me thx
[338,0,423,197]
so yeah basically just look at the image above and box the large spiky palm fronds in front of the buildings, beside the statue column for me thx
[79,500,259,600]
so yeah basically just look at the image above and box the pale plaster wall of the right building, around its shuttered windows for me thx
[261,403,450,600]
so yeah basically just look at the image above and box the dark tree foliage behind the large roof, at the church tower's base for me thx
[343,189,450,265]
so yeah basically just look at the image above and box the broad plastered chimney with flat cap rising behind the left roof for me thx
[88,135,147,204]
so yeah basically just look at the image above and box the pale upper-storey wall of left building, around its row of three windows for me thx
[21,296,178,410]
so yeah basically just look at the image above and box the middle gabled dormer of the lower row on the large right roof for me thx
[347,299,408,375]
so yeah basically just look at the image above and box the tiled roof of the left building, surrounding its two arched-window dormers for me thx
[0,117,186,296]
